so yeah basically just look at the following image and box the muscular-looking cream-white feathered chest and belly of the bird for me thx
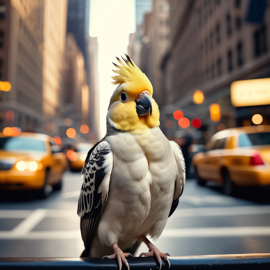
[98,128,177,245]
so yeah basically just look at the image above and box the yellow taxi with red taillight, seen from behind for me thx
[192,125,270,195]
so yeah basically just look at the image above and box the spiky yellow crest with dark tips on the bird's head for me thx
[112,55,153,96]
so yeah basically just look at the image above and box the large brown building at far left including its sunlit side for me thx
[0,0,67,133]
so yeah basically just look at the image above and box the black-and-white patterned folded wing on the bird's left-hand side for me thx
[77,140,113,257]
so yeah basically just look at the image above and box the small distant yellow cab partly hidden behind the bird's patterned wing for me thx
[67,143,93,171]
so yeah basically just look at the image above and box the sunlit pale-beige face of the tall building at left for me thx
[42,0,67,129]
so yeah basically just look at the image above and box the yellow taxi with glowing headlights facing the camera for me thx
[0,132,67,198]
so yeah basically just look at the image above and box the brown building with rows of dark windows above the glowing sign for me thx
[162,0,270,138]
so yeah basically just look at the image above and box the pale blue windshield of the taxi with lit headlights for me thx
[0,137,46,152]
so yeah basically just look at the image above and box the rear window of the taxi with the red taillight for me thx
[239,132,270,147]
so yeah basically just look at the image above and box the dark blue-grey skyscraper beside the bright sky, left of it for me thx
[67,0,90,84]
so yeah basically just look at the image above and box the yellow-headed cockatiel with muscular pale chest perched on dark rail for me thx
[78,55,185,270]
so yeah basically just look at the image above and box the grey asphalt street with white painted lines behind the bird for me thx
[0,172,270,257]
